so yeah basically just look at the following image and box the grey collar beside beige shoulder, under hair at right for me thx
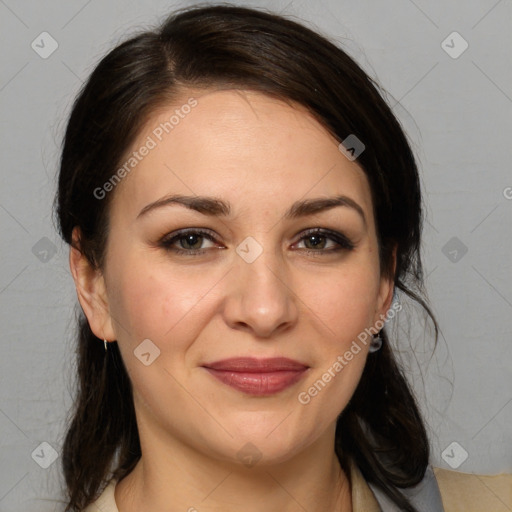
[368,465,444,512]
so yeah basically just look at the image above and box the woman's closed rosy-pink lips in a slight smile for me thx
[203,357,309,396]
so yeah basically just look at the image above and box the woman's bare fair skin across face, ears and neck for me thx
[70,90,393,512]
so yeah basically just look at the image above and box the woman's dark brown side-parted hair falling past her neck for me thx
[55,5,438,512]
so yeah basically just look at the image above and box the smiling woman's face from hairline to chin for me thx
[74,90,393,464]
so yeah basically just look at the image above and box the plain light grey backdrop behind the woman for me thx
[0,0,512,512]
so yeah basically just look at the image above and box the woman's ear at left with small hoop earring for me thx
[69,226,116,341]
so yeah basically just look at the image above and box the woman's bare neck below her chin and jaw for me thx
[115,422,352,512]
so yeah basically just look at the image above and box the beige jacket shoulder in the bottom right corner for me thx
[433,467,512,512]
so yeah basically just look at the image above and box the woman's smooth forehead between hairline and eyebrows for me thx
[111,90,372,226]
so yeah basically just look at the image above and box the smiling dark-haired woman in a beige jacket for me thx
[57,6,510,512]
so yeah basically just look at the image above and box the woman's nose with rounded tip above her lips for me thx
[224,246,298,338]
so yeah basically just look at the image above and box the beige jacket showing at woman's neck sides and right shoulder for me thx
[84,464,512,512]
